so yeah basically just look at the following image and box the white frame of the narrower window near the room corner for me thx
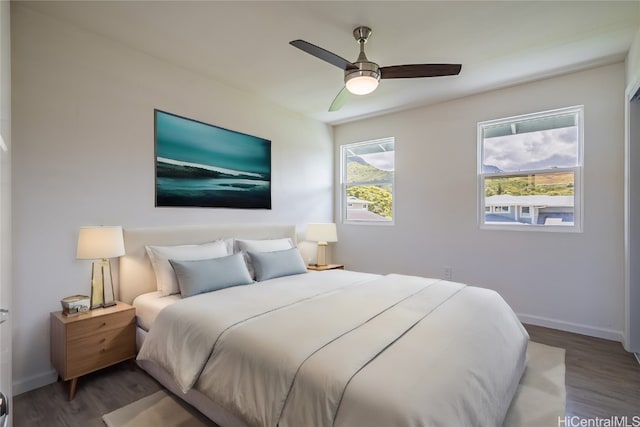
[339,136,396,226]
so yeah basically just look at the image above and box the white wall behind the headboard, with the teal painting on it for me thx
[11,2,333,393]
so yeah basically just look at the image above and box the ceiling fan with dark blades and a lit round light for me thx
[289,26,462,111]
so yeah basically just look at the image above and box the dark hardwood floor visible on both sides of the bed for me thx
[12,325,640,427]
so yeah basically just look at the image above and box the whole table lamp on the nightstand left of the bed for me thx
[76,226,124,310]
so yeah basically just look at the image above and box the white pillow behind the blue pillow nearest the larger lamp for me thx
[145,240,229,297]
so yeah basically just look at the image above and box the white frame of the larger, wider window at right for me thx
[477,105,584,233]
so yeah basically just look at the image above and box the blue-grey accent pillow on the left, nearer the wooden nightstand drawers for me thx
[169,253,253,298]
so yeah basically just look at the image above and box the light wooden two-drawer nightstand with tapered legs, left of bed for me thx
[50,301,136,400]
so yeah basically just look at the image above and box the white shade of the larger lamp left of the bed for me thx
[76,226,124,259]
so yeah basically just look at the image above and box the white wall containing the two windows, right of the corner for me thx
[334,63,625,340]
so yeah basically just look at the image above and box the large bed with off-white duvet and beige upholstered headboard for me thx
[119,224,528,427]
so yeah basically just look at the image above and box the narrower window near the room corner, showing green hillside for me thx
[341,138,395,224]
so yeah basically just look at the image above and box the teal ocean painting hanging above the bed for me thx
[154,110,271,209]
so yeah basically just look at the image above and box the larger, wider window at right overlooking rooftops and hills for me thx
[478,106,584,231]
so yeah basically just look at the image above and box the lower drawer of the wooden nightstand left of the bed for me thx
[67,324,136,378]
